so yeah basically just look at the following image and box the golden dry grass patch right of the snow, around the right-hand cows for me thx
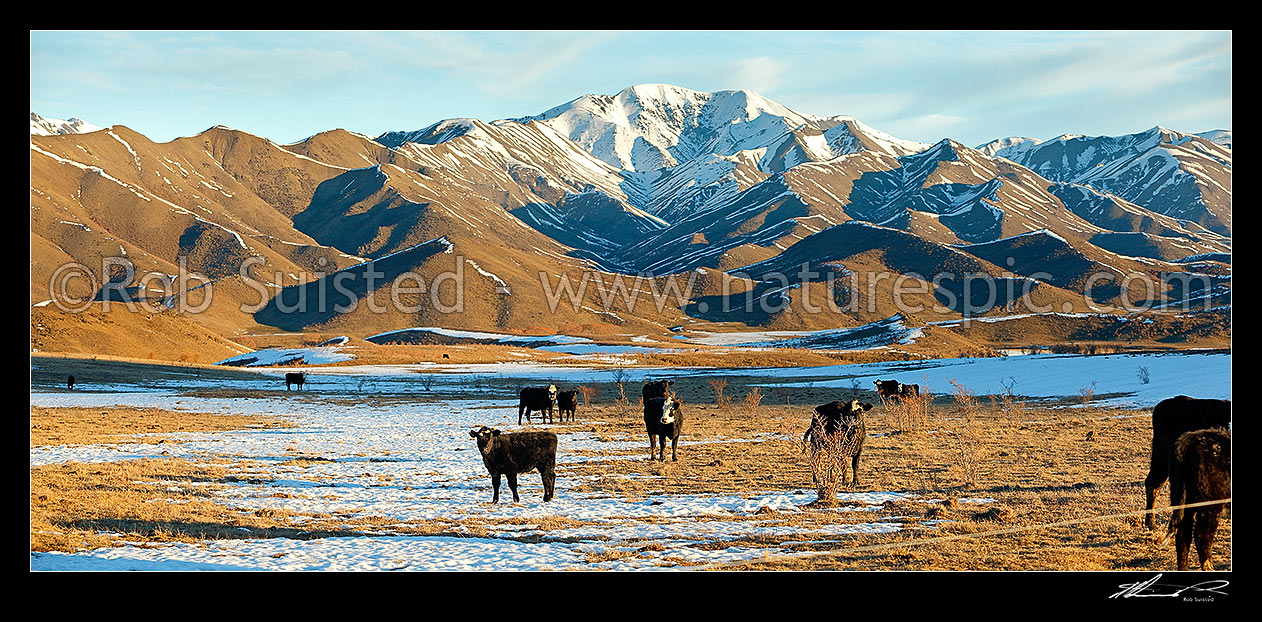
[558,401,1230,570]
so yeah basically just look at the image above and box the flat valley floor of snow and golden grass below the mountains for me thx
[30,355,1232,572]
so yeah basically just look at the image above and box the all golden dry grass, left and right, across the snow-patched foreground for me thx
[30,384,1232,570]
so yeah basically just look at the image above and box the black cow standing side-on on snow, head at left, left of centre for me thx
[469,425,557,503]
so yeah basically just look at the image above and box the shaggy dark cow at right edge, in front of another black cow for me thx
[1150,428,1232,570]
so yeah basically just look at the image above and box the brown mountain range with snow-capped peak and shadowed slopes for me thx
[30,85,1232,345]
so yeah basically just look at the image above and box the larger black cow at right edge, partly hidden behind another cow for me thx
[1143,395,1232,529]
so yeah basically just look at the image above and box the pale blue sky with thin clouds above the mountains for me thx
[30,30,1232,146]
